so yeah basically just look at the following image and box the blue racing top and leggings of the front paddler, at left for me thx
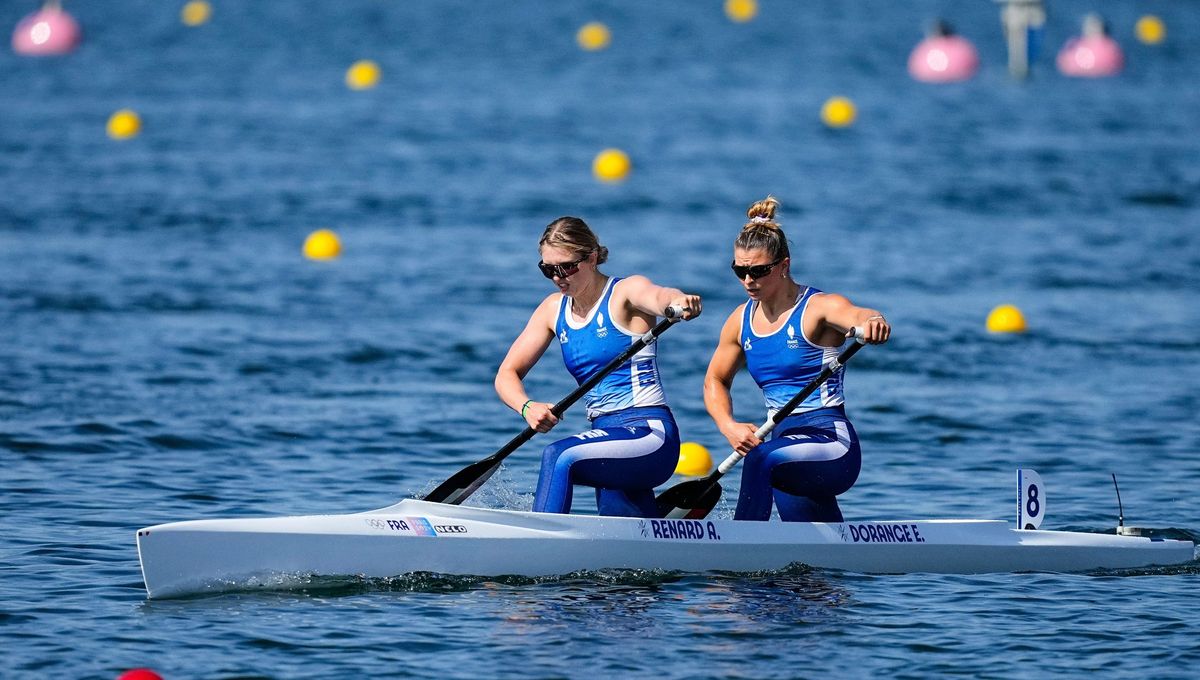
[533,278,679,517]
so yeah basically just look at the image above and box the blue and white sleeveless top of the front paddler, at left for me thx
[554,277,666,420]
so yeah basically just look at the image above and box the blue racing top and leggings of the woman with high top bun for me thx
[733,288,862,522]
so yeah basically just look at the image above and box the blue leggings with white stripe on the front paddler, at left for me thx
[533,407,679,517]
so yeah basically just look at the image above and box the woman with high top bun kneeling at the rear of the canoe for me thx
[704,195,892,522]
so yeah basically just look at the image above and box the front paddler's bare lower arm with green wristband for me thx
[496,293,562,432]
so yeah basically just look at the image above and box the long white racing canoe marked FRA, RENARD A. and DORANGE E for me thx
[137,500,1195,597]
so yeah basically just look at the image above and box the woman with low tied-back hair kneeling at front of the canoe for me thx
[496,217,701,517]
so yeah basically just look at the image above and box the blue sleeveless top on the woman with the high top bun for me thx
[740,288,846,413]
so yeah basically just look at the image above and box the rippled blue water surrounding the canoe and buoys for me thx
[0,0,1200,678]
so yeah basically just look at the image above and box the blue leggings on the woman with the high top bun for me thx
[733,407,863,522]
